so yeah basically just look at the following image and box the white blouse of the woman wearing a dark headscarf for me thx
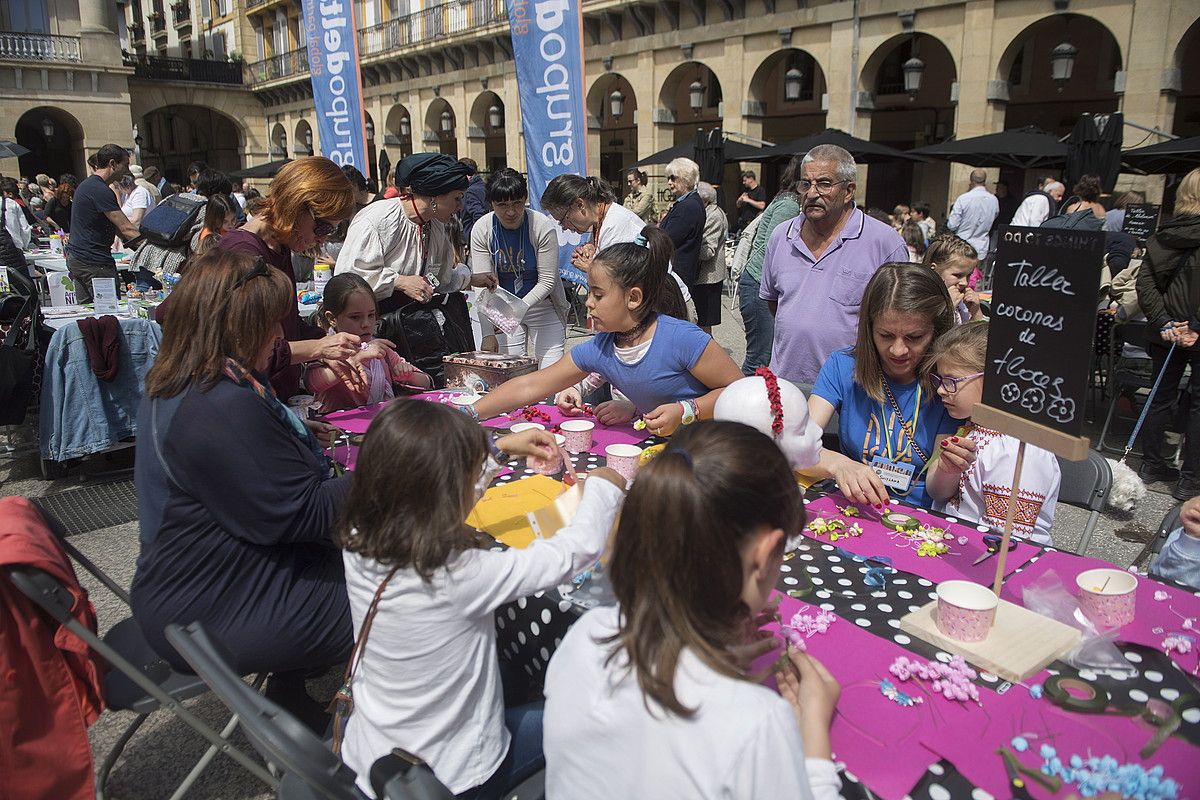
[334,198,470,300]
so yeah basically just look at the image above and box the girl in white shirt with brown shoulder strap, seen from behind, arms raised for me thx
[337,401,625,799]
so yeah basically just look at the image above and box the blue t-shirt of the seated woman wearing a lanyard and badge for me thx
[812,348,959,507]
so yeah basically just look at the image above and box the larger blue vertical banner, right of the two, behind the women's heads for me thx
[505,0,588,285]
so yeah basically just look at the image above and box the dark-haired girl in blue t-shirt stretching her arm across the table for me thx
[464,225,742,435]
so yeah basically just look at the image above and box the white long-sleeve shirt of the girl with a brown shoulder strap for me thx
[342,479,623,796]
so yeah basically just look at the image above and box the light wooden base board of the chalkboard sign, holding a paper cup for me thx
[900,600,1081,682]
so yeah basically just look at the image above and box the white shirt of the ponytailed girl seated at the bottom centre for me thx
[542,607,841,800]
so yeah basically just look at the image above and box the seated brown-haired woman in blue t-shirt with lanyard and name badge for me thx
[809,264,958,506]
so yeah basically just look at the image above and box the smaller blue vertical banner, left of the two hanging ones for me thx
[304,0,368,175]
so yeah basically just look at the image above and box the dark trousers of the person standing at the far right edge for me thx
[1141,344,1200,481]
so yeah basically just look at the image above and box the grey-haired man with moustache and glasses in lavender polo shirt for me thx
[758,144,908,390]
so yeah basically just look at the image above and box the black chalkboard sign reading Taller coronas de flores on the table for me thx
[976,227,1105,450]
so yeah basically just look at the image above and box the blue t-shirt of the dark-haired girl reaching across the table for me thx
[570,314,713,414]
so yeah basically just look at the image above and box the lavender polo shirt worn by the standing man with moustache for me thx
[758,207,908,385]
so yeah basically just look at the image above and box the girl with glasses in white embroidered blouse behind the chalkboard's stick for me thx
[926,320,1062,545]
